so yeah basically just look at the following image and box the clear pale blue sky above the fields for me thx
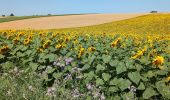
[0,0,170,15]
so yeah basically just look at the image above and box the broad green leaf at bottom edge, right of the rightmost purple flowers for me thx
[143,87,156,99]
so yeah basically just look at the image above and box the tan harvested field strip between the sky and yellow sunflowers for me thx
[0,14,144,30]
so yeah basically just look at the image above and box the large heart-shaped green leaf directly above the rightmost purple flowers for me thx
[128,71,140,85]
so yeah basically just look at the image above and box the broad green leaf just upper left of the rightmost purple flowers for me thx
[118,78,132,91]
